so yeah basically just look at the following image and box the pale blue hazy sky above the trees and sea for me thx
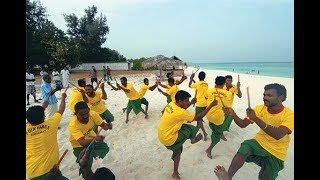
[36,0,294,62]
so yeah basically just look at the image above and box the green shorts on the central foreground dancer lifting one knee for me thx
[166,124,199,159]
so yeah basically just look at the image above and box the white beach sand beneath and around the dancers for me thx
[26,67,294,180]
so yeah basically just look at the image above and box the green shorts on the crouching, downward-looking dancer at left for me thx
[73,141,109,175]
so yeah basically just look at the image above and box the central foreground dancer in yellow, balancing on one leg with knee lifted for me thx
[158,90,217,179]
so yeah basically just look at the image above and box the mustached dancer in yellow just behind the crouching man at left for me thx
[85,83,114,122]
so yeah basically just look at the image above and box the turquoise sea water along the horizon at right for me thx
[187,62,294,78]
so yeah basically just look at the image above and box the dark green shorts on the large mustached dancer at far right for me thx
[238,139,284,180]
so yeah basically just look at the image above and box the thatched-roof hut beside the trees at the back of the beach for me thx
[142,55,186,69]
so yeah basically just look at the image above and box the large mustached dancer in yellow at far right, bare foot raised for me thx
[216,83,294,179]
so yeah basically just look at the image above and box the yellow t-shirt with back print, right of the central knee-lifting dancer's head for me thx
[205,88,232,125]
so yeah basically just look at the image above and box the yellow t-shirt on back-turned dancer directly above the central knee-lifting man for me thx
[190,81,208,107]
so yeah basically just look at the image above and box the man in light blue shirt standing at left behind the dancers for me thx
[41,74,62,118]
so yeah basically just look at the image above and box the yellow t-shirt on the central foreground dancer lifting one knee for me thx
[158,102,195,146]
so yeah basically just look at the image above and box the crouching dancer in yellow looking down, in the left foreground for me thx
[68,101,112,177]
